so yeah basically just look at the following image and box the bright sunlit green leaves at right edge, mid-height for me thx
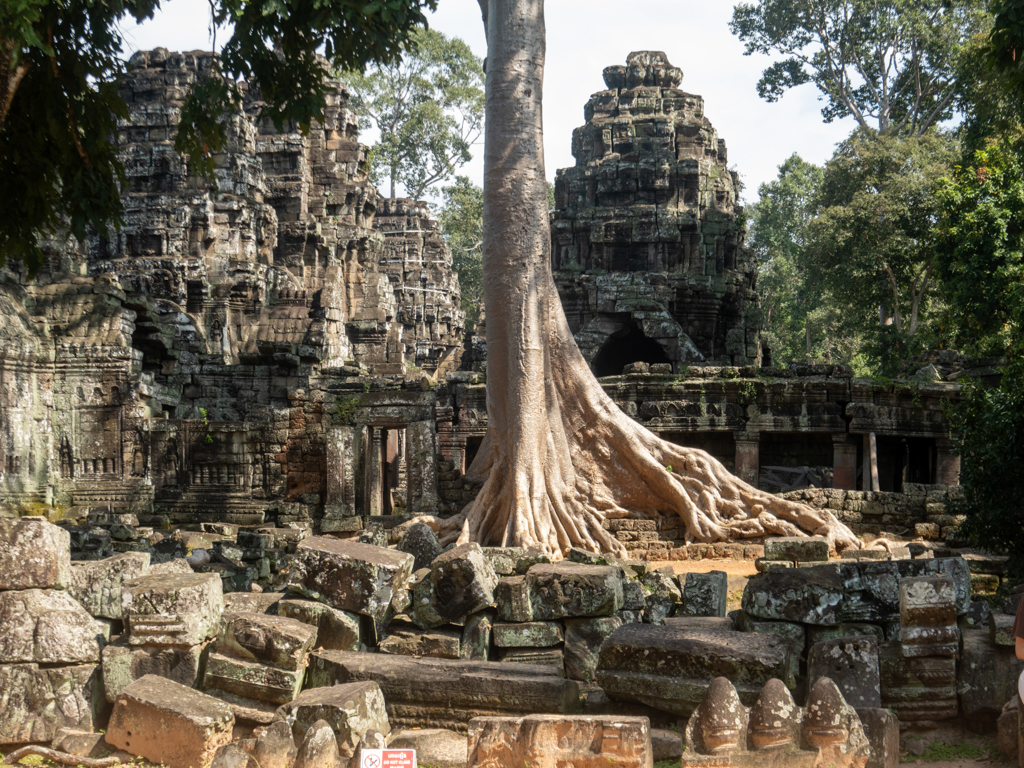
[936,144,1024,356]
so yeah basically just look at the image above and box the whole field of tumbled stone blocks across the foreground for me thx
[0,517,1024,768]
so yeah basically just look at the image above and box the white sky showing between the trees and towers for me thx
[117,0,854,202]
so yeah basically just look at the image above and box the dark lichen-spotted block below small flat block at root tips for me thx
[742,565,843,627]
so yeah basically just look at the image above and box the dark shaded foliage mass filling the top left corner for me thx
[0,0,157,272]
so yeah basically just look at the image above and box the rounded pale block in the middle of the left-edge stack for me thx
[0,589,104,664]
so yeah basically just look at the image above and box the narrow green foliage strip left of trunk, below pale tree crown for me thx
[438,176,483,329]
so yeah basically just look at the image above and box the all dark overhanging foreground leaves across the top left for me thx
[0,0,436,271]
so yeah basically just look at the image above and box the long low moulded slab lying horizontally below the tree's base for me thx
[306,650,580,730]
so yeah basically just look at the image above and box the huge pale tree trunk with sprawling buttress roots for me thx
[428,0,859,557]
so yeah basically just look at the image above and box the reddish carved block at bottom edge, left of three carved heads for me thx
[466,715,654,768]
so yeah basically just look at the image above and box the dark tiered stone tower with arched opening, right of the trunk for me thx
[552,51,762,376]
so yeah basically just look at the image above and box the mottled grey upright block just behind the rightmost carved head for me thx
[807,637,882,712]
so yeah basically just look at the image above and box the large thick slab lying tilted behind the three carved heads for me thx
[597,624,796,717]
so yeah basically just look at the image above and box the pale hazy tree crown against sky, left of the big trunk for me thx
[341,30,483,199]
